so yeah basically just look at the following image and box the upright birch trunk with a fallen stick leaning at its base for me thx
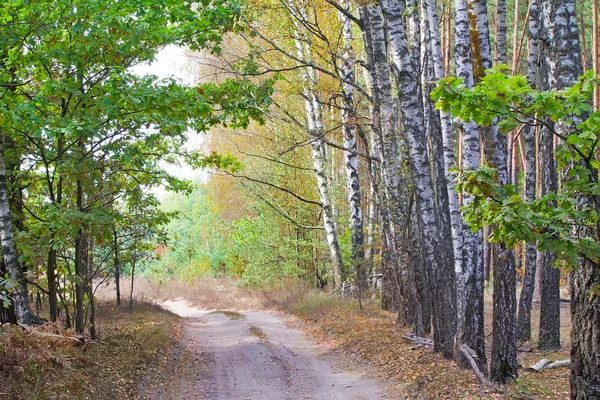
[455,0,487,373]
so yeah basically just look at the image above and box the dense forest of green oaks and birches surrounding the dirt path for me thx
[0,0,600,400]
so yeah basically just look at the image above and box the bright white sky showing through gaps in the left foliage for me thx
[132,45,208,199]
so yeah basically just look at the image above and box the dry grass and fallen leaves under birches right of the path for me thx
[287,292,570,400]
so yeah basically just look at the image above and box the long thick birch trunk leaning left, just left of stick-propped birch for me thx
[382,0,456,358]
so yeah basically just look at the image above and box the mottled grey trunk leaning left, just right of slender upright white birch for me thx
[361,5,420,318]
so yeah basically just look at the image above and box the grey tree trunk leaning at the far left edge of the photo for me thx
[0,134,43,325]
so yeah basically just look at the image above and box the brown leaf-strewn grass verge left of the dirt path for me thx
[0,301,181,400]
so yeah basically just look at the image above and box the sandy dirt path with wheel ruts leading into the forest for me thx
[161,300,385,400]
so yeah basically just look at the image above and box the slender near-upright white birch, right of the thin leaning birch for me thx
[340,1,368,294]
